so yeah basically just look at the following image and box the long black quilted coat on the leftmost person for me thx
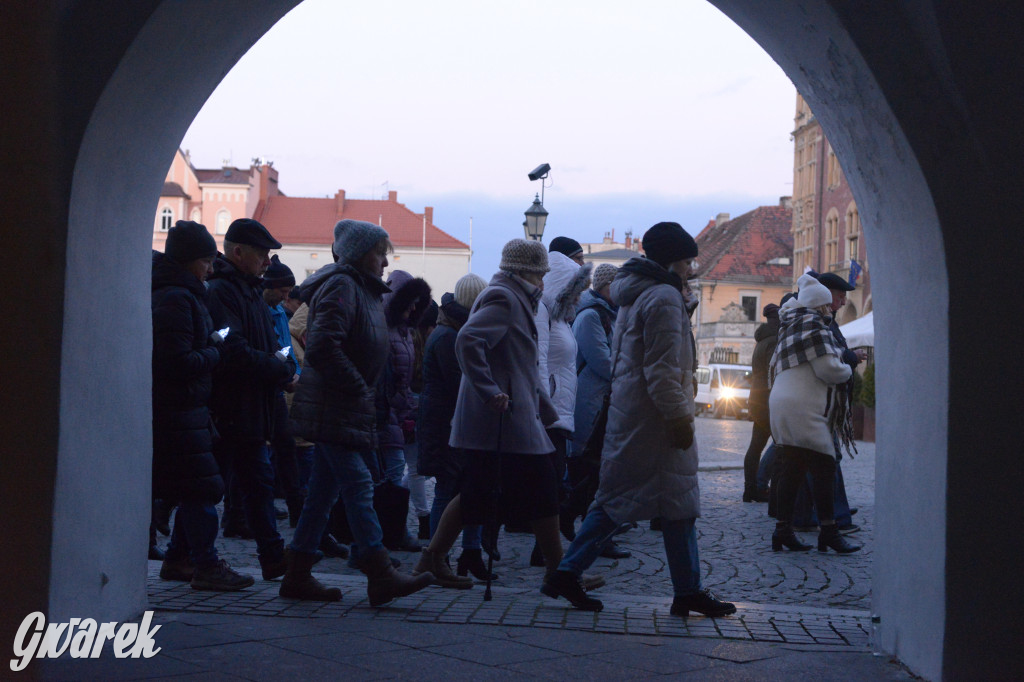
[153,254,224,504]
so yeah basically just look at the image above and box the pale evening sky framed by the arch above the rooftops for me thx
[181,0,796,276]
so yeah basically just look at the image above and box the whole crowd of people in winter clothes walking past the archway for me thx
[151,219,860,617]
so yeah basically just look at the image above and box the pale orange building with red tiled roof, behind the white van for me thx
[690,197,793,365]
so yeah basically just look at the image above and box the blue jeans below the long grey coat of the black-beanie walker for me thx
[558,507,700,597]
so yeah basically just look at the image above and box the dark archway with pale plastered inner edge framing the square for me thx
[0,0,1024,678]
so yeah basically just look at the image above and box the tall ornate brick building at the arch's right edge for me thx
[793,93,871,325]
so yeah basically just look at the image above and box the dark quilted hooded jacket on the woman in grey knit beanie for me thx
[291,263,390,450]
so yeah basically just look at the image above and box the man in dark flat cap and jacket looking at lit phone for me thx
[203,218,295,580]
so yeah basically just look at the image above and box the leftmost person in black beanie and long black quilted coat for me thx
[153,220,254,591]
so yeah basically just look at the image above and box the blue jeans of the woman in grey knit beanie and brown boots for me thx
[291,442,385,557]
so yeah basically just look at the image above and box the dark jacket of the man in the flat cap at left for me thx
[203,256,295,441]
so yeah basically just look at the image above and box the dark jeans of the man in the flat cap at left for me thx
[213,437,285,563]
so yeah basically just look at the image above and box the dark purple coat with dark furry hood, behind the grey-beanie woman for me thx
[377,270,430,450]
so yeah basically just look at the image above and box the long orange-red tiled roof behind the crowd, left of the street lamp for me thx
[253,196,469,249]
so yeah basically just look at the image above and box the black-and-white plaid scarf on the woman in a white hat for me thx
[768,306,857,457]
